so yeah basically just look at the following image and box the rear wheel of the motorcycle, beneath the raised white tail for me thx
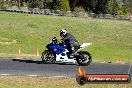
[76,51,92,66]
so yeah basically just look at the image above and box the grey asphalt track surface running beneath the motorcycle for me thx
[0,59,132,77]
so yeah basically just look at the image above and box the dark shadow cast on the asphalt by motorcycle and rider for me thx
[12,59,76,65]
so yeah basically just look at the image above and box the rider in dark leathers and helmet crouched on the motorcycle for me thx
[60,29,79,55]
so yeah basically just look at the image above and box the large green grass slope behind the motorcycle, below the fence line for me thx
[0,12,132,61]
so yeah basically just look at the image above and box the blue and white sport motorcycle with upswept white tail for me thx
[41,37,92,66]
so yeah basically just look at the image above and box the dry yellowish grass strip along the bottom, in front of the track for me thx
[0,76,132,88]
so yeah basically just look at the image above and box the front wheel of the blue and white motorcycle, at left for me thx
[41,50,55,64]
